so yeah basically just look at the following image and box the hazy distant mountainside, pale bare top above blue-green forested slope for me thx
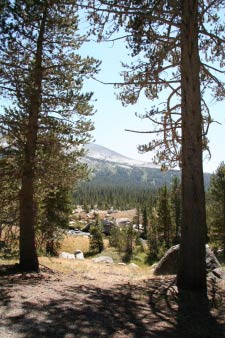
[85,144,210,189]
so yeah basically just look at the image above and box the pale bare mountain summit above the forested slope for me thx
[86,143,159,168]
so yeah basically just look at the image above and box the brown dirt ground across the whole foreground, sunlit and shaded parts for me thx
[0,264,225,338]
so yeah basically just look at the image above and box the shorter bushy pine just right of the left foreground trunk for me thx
[35,128,88,254]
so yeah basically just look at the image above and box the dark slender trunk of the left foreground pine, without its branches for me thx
[20,8,47,271]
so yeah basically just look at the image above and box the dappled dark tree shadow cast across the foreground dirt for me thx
[1,266,225,338]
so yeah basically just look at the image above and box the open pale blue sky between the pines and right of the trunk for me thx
[82,37,225,172]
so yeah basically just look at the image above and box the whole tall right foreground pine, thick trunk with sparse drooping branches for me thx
[82,0,225,291]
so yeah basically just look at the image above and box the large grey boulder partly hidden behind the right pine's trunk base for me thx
[154,245,223,277]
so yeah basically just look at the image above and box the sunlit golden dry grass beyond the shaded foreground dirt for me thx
[0,236,152,280]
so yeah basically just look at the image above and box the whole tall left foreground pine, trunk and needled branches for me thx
[0,0,97,271]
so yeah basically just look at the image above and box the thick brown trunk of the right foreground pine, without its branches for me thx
[178,0,206,291]
